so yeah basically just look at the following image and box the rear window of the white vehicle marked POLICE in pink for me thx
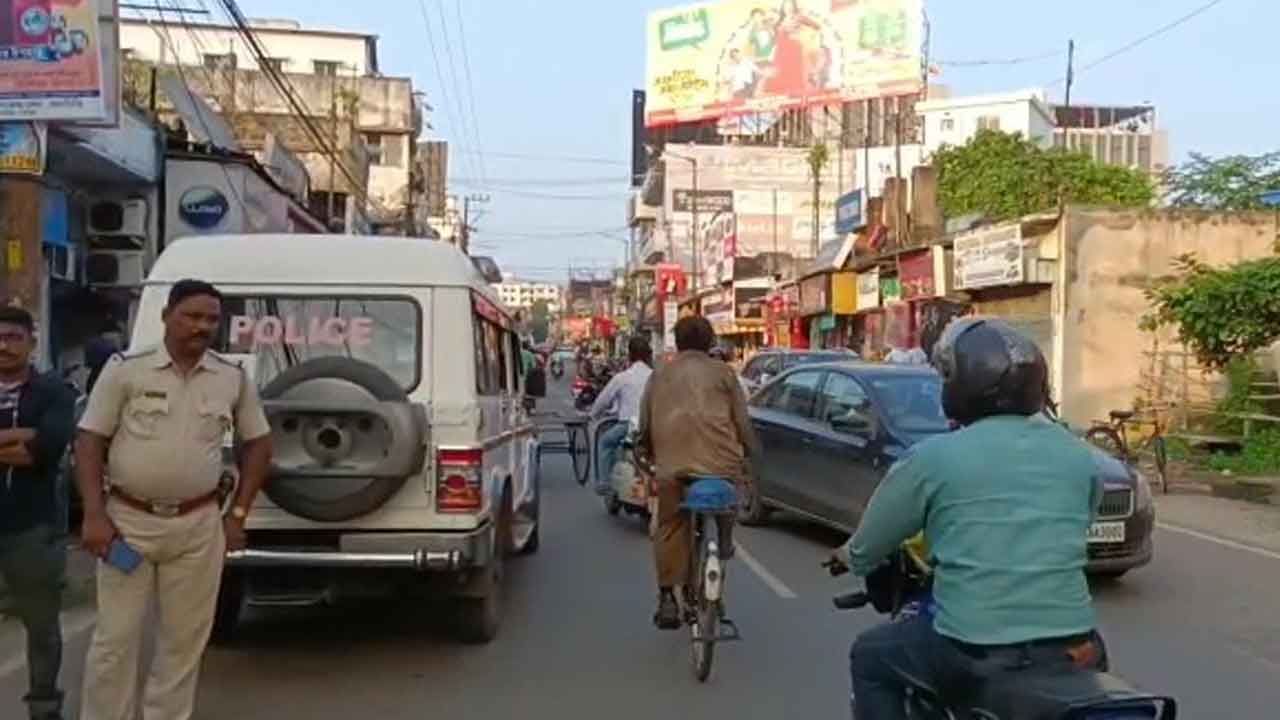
[218,296,422,392]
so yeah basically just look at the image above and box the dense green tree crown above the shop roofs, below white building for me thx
[933,129,1155,220]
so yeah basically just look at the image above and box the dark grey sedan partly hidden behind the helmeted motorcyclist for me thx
[742,363,1155,575]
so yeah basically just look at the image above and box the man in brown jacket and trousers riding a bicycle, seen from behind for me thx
[639,316,759,630]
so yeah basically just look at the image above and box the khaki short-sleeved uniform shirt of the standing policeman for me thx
[79,345,271,501]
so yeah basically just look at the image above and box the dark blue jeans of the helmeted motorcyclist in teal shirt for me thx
[849,615,1106,720]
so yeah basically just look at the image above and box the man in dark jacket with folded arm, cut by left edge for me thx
[0,307,76,720]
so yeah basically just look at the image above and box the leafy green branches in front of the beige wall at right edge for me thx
[1142,254,1280,368]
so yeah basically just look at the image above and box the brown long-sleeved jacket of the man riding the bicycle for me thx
[640,352,758,480]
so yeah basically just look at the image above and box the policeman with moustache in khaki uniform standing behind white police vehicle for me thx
[76,279,271,720]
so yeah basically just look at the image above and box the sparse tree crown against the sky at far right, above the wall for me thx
[1165,151,1280,210]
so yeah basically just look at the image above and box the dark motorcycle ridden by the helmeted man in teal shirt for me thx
[823,539,1178,720]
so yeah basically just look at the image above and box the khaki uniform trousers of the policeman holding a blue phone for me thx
[81,500,227,720]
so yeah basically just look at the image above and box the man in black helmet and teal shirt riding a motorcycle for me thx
[833,318,1103,720]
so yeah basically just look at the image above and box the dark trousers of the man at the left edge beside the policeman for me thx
[0,525,67,719]
